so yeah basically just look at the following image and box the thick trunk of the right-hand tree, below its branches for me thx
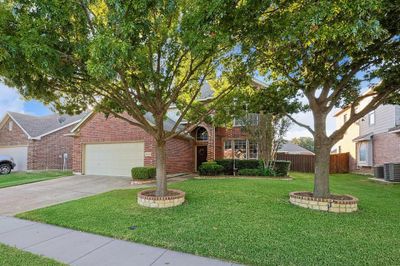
[314,112,332,198]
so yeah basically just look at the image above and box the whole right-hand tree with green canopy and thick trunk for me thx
[240,0,400,198]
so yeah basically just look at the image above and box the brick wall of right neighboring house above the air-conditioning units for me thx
[373,133,400,165]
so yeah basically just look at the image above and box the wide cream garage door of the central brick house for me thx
[85,142,144,176]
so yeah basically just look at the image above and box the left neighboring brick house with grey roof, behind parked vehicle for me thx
[0,112,84,171]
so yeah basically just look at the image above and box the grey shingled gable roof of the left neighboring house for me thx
[3,112,86,139]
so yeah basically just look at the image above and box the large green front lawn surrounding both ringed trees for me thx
[18,173,400,265]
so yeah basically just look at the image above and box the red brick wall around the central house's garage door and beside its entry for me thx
[73,114,194,174]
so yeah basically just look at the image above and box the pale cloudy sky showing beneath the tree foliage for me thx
[0,83,335,139]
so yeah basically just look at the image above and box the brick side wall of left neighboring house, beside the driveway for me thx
[28,125,74,170]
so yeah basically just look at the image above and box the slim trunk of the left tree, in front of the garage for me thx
[156,141,167,197]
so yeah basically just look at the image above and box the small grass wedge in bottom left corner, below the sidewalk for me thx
[0,244,65,266]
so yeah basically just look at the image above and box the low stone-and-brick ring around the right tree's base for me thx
[289,191,358,213]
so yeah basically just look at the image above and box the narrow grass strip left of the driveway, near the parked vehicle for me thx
[0,171,72,188]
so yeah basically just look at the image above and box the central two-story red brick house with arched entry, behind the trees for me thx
[70,80,312,176]
